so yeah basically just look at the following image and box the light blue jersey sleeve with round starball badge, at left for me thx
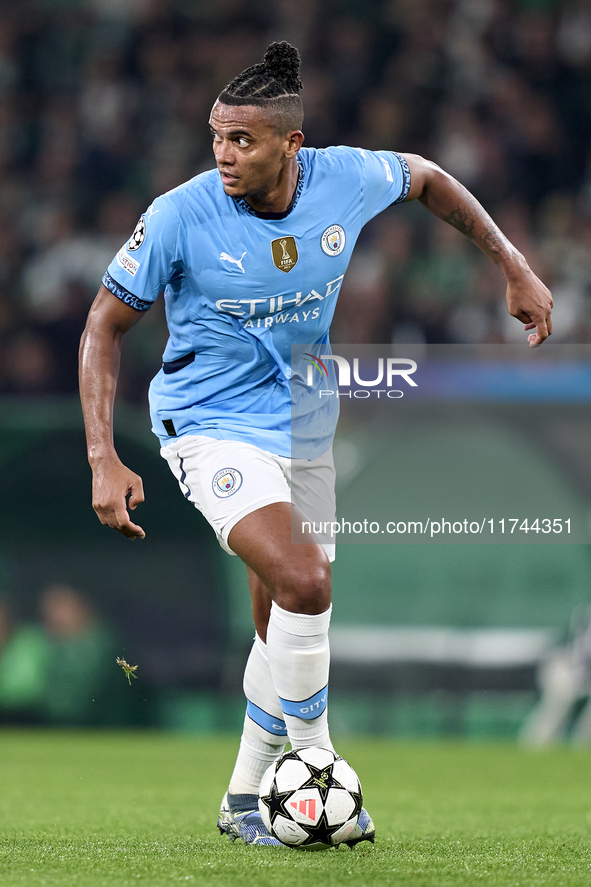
[102,195,181,311]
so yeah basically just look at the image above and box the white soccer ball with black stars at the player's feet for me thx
[259,746,363,850]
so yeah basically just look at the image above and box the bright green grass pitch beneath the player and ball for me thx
[0,730,591,887]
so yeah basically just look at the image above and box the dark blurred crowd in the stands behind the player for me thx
[0,0,591,403]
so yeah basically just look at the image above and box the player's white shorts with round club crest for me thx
[160,435,336,561]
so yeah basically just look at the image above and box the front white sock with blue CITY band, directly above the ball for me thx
[267,602,334,750]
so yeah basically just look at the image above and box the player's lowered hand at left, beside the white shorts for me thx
[92,460,146,539]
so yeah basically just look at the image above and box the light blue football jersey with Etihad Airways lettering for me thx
[103,147,410,458]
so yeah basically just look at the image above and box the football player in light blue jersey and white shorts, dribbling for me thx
[80,43,552,844]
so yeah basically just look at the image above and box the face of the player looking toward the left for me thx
[209,102,297,198]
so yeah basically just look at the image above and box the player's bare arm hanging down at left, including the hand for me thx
[79,285,146,539]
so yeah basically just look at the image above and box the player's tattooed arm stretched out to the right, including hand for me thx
[403,154,553,347]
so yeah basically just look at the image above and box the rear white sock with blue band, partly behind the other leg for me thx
[228,635,287,795]
